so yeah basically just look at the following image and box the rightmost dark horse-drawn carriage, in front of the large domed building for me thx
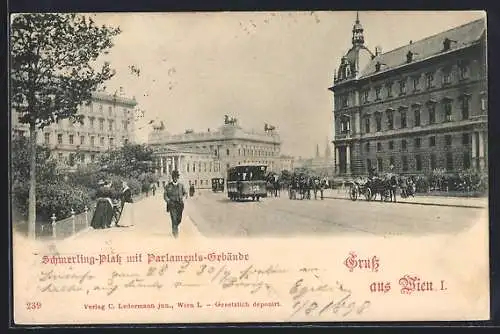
[349,175,398,202]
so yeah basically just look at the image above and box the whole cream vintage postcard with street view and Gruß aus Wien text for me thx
[10,11,490,326]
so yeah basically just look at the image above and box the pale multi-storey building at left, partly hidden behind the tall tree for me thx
[11,92,137,167]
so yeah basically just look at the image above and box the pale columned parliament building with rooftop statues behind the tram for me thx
[148,117,281,188]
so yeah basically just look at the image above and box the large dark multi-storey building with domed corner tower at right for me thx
[329,16,488,176]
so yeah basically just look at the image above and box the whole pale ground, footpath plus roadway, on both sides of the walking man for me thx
[65,190,487,239]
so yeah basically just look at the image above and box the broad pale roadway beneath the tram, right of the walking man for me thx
[186,191,486,237]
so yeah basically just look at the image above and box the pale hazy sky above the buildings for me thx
[89,11,485,157]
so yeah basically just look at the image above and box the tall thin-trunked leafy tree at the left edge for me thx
[11,13,120,237]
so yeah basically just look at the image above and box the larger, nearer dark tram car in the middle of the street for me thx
[227,164,267,201]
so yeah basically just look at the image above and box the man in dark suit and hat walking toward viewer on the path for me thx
[163,170,187,238]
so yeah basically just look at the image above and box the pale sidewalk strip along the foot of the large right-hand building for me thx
[324,188,488,209]
